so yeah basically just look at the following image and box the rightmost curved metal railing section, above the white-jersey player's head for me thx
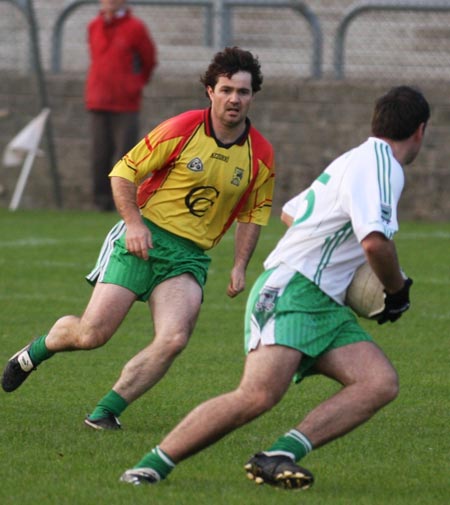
[333,0,450,79]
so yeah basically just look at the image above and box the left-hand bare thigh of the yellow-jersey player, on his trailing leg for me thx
[81,282,136,341]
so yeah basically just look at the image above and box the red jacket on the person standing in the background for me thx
[85,9,157,112]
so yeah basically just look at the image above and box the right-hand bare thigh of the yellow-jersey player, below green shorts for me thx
[150,273,202,337]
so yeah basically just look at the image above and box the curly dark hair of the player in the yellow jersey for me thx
[200,47,263,93]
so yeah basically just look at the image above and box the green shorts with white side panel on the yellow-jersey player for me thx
[86,219,211,301]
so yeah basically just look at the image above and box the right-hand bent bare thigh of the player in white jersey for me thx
[314,341,398,385]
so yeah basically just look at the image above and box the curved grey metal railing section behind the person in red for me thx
[51,0,215,74]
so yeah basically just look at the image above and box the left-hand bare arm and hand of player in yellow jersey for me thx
[111,177,153,260]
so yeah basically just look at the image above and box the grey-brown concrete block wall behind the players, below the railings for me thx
[0,75,450,220]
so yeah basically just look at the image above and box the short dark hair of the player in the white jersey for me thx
[372,86,430,140]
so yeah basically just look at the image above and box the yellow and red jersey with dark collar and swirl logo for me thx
[110,109,274,249]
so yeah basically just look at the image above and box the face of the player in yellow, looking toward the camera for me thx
[207,71,253,128]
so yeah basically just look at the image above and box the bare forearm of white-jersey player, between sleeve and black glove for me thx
[361,232,405,293]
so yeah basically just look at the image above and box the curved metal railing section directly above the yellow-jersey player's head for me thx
[221,0,323,79]
